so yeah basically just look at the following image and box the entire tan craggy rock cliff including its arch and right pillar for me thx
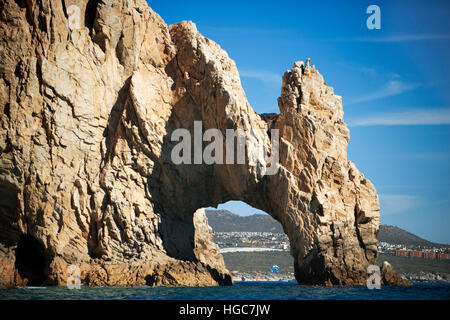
[0,0,408,286]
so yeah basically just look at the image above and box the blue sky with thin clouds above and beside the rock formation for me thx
[149,0,450,243]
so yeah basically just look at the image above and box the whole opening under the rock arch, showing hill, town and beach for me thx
[205,201,295,281]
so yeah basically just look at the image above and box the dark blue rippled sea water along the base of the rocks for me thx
[0,282,450,300]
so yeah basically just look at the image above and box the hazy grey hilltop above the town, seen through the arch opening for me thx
[206,210,284,233]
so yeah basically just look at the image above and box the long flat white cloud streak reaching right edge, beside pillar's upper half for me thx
[348,108,450,127]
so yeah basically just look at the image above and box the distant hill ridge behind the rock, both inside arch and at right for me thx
[206,210,448,248]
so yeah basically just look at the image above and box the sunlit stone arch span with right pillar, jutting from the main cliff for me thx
[139,23,379,284]
